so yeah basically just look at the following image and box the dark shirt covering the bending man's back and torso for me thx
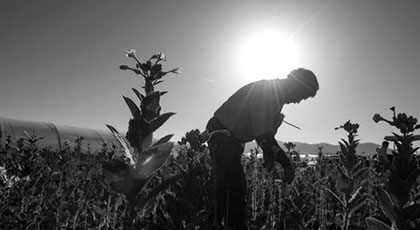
[214,79,285,143]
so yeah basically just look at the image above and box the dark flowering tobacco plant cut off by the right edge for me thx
[366,107,420,230]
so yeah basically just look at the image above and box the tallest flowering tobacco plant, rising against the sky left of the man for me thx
[103,49,179,227]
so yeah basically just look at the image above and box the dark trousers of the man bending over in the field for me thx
[207,118,247,230]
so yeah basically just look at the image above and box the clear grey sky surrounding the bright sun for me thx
[0,0,420,144]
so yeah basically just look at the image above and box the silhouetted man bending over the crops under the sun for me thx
[206,68,319,229]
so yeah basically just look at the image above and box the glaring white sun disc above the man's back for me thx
[239,32,298,80]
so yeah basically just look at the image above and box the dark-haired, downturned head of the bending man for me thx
[285,68,319,104]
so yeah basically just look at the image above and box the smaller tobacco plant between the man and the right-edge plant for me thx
[326,121,368,230]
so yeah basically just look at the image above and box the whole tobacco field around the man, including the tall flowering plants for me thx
[0,50,420,230]
